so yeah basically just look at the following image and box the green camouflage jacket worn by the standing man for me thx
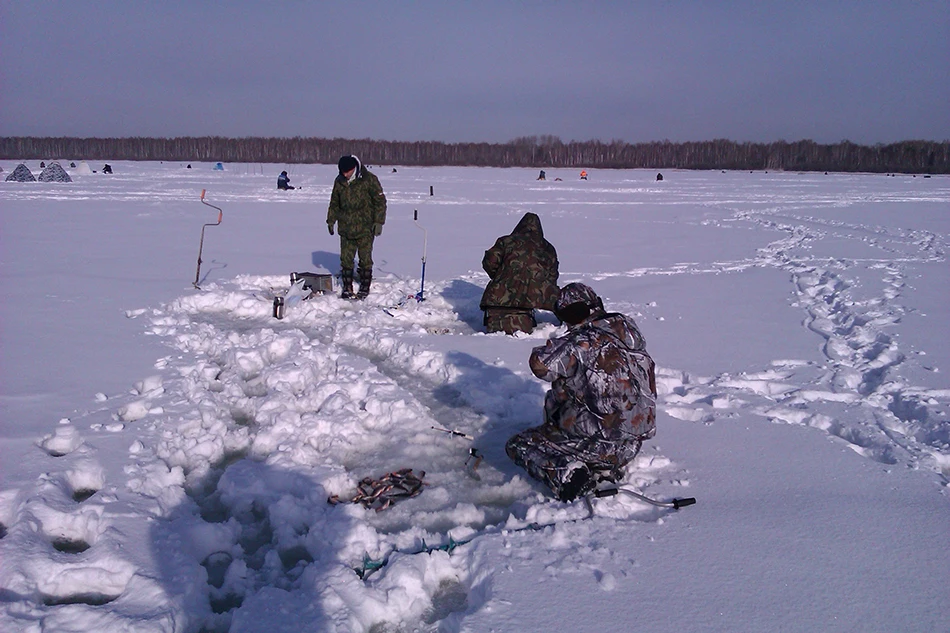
[327,165,386,240]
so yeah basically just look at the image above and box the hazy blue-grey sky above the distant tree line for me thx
[0,0,950,144]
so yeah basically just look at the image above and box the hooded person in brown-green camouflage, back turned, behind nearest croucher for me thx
[480,212,558,334]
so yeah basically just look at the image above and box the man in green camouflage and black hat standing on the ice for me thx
[327,156,386,299]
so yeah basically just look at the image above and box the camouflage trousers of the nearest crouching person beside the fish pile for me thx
[505,424,643,498]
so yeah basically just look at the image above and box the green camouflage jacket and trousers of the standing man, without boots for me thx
[327,157,386,270]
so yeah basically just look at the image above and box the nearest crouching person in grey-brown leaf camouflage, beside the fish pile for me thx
[505,283,656,501]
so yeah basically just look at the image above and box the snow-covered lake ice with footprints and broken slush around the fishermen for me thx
[0,161,950,633]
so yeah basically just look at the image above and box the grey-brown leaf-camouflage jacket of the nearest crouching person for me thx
[529,310,656,441]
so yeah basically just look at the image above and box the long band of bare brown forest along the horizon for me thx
[0,136,950,174]
